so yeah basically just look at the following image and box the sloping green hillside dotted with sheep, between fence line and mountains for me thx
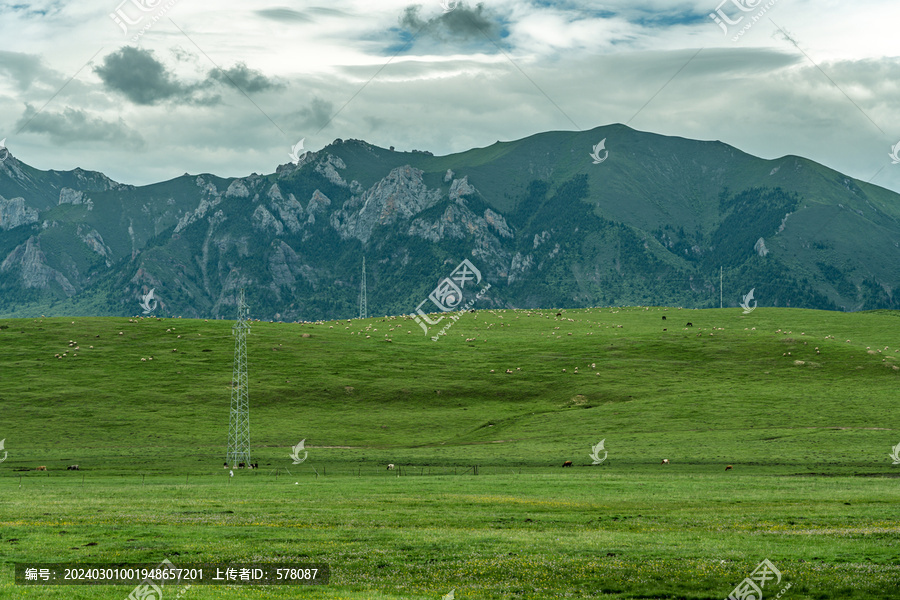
[0,308,900,472]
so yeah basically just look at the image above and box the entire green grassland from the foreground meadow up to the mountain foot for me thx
[0,307,900,600]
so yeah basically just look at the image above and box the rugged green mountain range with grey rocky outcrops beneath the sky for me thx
[0,124,900,321]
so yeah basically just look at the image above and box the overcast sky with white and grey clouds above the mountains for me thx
[0,0,900,191]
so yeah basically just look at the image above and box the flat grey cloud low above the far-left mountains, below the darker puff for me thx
[17,104,147,149]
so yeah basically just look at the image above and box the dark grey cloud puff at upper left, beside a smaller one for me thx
[94,46,197,105]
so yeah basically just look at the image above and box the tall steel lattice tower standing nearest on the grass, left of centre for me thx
[225,288,250,466]
